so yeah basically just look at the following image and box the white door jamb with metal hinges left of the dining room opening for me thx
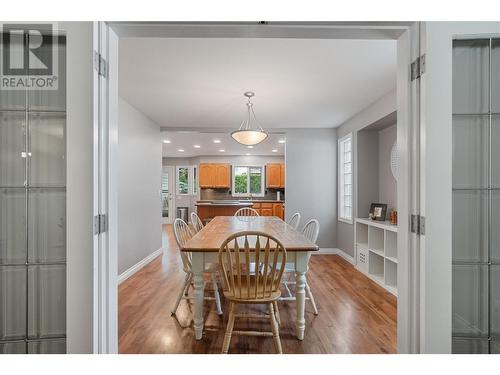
[93,22,118,353]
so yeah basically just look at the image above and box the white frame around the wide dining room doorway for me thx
[99,22,419,353]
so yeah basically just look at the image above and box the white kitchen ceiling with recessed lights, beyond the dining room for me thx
[162,131,285,158]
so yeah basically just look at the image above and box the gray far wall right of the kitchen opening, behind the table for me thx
[285,129,337,248]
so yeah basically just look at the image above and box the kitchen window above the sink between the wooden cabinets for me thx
[232,165,264,197]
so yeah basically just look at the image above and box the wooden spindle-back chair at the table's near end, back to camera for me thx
[219,231,286,354]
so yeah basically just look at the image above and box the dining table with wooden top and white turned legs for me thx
[181,216,319,340]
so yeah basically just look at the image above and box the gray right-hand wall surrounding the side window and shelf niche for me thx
[337,90,396,257]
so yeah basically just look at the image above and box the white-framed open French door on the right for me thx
[420,22,500,353]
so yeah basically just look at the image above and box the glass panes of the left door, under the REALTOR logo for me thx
[0,24,66,354]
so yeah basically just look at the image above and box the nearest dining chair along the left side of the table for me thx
[172,219,222,315]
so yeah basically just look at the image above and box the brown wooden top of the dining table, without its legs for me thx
[181,216,319,252]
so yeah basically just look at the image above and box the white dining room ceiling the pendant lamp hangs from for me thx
[119,38,396,129]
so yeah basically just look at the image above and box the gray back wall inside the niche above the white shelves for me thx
[378,124,398,213]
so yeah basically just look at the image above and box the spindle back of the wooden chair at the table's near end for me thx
[219,231,286,301]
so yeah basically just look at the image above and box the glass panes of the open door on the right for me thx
[452,38,500,353]
